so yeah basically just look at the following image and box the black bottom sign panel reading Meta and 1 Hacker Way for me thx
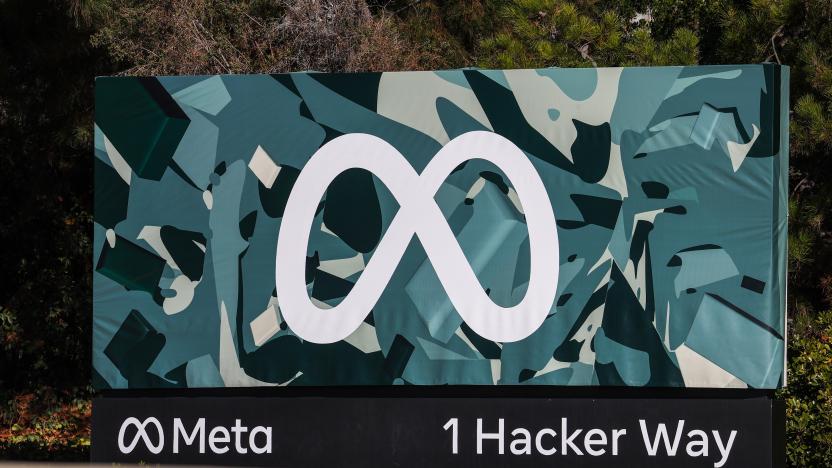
[92,397,782,468]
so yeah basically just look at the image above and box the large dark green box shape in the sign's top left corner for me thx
[95,77,190,180]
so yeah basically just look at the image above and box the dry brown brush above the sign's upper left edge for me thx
[92,0,431,75]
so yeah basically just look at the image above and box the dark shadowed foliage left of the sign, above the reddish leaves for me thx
[0,1,105,393]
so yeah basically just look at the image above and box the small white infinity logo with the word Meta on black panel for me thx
[118,416,272,455]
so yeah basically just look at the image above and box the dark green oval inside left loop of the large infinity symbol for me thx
[324,169,381,253]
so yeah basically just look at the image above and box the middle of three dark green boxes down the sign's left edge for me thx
[95,236,165,303]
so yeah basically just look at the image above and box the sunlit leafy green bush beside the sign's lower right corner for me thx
[778,312,832,466]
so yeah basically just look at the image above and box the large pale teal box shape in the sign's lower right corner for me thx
[685,295,783,388]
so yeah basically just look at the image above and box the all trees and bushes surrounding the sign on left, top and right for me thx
[0,0,832,466]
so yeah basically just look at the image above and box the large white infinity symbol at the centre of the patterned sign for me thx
[275,131,559,343]
